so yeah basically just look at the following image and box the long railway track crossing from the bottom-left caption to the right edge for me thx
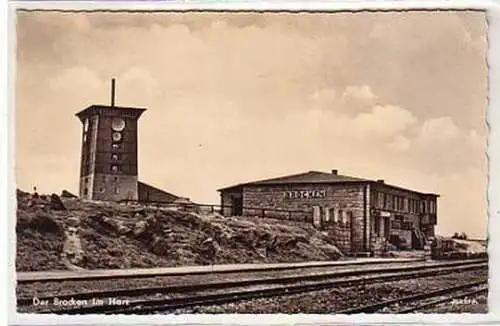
[18,260,488,314]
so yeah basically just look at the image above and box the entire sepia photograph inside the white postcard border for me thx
[14,9,489,315]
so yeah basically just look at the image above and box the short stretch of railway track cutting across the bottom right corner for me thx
[335,279,488,314]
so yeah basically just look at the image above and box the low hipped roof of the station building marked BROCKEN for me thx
[218,170,439,196]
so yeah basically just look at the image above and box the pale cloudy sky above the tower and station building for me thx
[16,11,487,237]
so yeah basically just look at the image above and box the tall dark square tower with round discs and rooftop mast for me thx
[76,79,145,201]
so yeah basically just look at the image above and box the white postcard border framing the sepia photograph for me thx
[0,0,500,325]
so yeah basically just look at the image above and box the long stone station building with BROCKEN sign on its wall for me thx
[219,170,439,256]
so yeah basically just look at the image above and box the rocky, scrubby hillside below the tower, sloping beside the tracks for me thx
[16,191,341,271]
